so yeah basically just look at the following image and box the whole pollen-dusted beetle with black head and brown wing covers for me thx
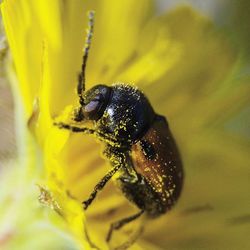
[55,12,183,245]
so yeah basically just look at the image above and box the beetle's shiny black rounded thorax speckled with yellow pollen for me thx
[97,84,155,143]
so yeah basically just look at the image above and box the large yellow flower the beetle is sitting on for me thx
[0,0,250,249]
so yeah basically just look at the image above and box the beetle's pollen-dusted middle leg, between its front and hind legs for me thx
[82,153,125,210]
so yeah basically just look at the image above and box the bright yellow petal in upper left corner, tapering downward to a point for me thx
[1,0,42,115]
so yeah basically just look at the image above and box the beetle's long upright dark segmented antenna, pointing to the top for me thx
[77,11,95,105]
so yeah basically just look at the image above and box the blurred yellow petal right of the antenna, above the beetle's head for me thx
[87,0,154,86]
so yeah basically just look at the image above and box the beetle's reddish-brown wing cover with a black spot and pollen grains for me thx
[131,118,183,210]
